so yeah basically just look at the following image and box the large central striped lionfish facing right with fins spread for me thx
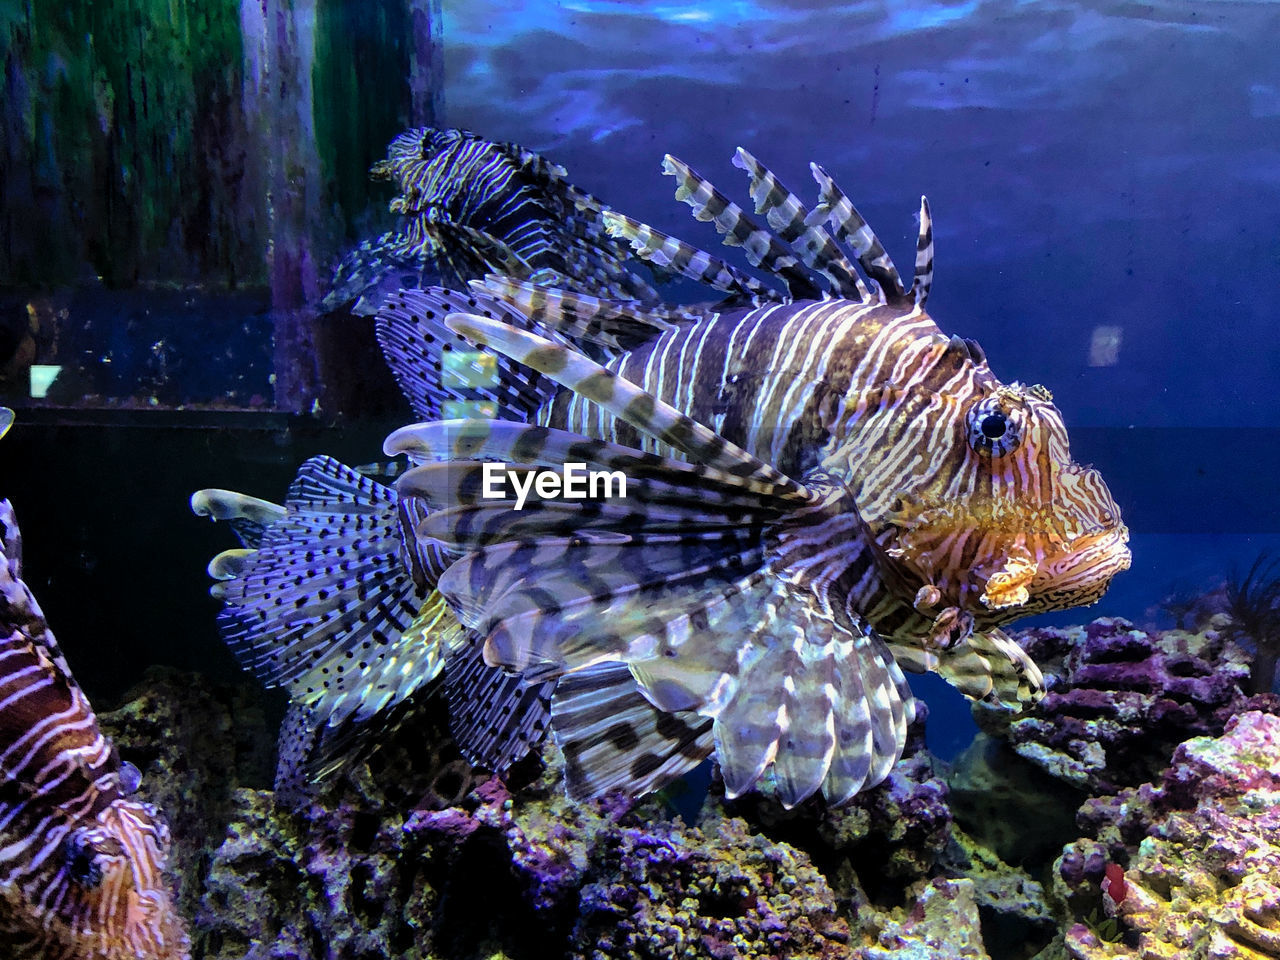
[192,133,1129,806]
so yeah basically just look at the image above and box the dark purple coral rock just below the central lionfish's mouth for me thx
[979,617,1249,794]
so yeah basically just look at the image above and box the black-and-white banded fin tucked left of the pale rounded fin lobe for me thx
[552,662,714,799]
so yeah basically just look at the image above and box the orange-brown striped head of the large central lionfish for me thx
[882,360,1130,626]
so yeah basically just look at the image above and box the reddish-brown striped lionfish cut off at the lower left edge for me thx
[0,417,188,960]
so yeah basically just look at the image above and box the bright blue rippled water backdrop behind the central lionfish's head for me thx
[432,0,1280,617]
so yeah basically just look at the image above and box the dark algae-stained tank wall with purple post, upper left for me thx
[0,0,443,412]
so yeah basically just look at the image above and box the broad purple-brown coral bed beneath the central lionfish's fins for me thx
[85,671,1075,960]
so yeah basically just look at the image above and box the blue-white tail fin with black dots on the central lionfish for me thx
[213,457,461,724]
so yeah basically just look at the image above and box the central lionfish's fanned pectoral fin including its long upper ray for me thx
[399,317,914,805]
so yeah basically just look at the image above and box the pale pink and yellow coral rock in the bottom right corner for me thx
[1057,710,1280,960]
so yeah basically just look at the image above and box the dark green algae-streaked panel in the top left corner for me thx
[0,0,253,285]
